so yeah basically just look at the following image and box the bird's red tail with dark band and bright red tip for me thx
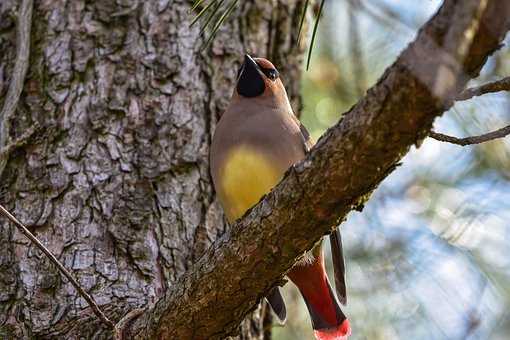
[288,256,351,340]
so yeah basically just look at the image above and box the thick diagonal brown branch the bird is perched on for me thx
[120,0,510,339]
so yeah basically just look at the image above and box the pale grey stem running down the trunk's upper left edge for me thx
[0,0,34,176]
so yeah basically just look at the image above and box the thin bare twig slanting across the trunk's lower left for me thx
[0,204,115,329]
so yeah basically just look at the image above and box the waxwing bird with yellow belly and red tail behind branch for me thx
[209,54,351,340]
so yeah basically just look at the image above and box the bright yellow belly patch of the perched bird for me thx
[220,146,285,222]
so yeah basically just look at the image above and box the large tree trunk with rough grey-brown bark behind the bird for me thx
[0,0,303,339]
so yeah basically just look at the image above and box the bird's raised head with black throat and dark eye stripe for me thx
[236,54,287,100]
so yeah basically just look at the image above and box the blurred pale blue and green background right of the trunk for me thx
[273,0,510,340]
